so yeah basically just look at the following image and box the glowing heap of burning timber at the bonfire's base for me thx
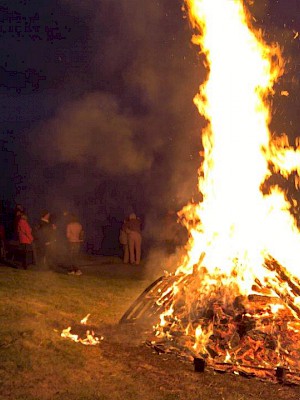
[120,258,300,384]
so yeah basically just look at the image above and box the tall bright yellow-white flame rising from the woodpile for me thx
[158,0,300,374]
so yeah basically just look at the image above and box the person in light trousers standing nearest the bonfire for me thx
[126,213,142,265]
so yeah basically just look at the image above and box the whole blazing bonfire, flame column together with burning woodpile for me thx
[156,0,300,382]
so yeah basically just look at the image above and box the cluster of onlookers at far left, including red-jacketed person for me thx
[0,204,84,275]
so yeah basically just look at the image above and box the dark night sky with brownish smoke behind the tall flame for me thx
[0,0,300,231]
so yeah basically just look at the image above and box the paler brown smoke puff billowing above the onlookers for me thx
[33,93,155,175]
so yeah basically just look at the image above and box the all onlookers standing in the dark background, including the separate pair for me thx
[0,204,142,275]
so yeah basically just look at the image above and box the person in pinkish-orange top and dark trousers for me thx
[66,214,84,275]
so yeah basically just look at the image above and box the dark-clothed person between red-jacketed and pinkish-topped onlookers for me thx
[34,210,54,268]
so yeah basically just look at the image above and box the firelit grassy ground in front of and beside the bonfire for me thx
[0,259,300,400]
